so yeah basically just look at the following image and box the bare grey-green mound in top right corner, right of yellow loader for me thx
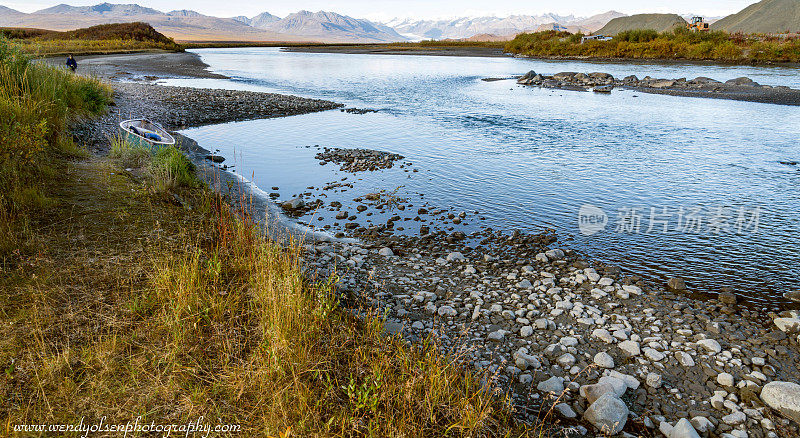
[711,0,800,33]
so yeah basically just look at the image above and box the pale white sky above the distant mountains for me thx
[0,0,757,20]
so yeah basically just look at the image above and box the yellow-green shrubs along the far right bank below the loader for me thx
[505,28,800,63]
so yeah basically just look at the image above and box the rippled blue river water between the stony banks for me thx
[164,48,800,305]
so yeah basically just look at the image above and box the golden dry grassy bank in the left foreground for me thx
[0,36,535,436]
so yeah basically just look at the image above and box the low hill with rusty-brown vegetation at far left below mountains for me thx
[0,23,183,56]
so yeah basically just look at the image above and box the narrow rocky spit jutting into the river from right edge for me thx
[517,70,800,105]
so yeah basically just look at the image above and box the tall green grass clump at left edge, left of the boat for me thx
[0,38,111,261]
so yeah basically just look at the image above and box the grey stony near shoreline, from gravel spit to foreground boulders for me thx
[76,52,800,438]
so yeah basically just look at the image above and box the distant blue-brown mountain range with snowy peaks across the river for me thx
[0,3,624,43]
